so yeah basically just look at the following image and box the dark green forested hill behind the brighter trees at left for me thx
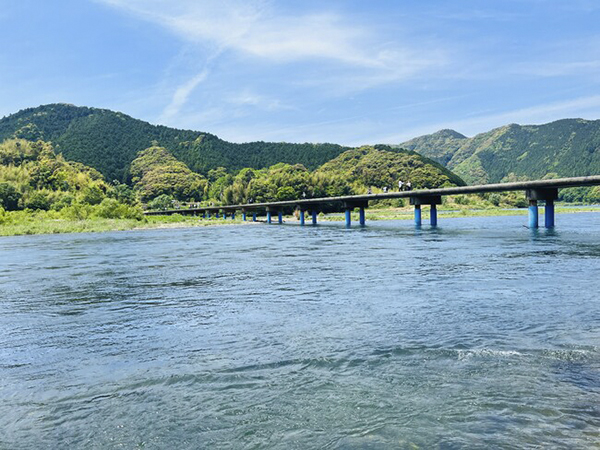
[0,104,348,181]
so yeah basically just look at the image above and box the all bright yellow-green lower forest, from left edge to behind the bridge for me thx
[0,135,464,218]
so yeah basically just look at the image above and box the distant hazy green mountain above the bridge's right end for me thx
[400,119,600,184]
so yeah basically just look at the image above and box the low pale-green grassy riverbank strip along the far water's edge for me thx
[0,205,600,236]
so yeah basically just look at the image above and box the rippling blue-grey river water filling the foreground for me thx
[0,213,600,450]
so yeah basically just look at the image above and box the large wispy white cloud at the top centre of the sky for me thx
[99,0,446,73]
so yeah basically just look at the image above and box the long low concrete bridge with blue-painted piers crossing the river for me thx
[145,175,600,228]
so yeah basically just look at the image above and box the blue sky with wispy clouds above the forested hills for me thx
[0,0,600,145]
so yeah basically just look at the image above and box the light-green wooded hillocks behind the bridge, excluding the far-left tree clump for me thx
[136,146,464,209]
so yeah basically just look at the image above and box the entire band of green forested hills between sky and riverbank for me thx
[0,104,600,217]
